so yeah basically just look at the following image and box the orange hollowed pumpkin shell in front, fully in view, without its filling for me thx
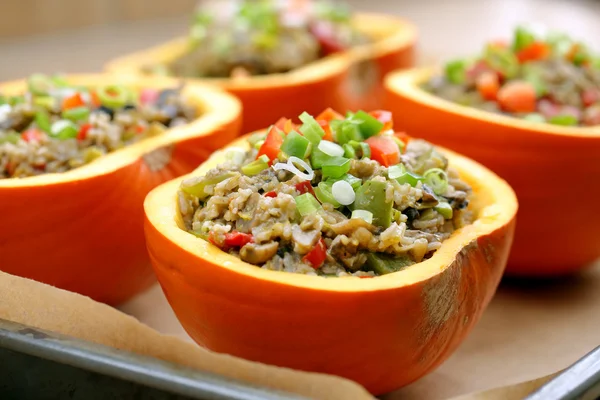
[144,134,517,394]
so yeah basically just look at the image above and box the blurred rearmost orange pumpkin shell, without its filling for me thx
[106,14,417,132]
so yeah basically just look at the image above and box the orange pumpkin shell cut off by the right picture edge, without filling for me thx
[386,69,600,276]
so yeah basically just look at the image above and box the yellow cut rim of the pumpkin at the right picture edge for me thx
[384,67,600,137]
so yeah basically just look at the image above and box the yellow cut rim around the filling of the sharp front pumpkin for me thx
[144,133,518,292]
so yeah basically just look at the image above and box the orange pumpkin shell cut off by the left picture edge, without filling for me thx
[0,75,240,304]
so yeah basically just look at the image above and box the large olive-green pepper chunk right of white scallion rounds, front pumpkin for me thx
[353,181,394,228]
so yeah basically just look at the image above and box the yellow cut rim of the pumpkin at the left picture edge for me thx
[0,74,242,189]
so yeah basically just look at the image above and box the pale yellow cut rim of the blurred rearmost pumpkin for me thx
[105,13,417,91]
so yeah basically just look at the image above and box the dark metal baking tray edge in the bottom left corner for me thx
[0,319,307,400]
